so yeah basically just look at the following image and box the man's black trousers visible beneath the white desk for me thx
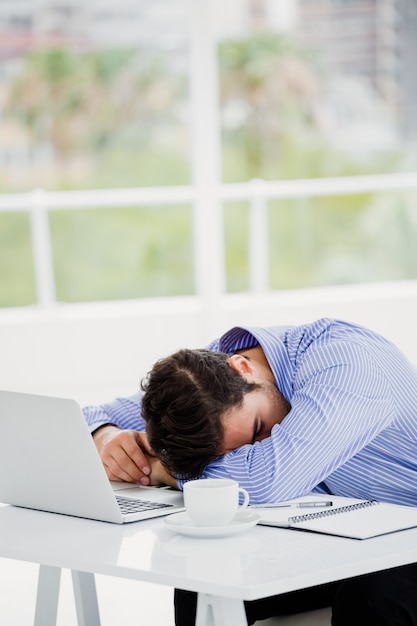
[174,564,417,626]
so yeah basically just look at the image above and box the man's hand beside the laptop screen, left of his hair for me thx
[93,424,156,485]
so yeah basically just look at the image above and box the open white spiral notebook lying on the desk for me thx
[258,496,417,539]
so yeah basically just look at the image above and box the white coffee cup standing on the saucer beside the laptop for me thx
[184,478,249,526]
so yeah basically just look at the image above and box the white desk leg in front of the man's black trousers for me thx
[195,593,248,626]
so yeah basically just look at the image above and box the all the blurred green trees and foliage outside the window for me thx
[0,35,417,307]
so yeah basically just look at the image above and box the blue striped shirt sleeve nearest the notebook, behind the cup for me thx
[200,342,394,503]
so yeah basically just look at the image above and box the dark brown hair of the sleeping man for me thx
[141,349,258,479]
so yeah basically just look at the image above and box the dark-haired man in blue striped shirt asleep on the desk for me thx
[84,318,417,626]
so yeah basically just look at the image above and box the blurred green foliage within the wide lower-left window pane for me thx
[51,207,193,302]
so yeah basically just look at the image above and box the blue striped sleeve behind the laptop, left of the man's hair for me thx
[83,392,145,433]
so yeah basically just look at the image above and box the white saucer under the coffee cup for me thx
[163,510,261,537]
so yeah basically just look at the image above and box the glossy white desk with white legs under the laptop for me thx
[0,506,417,626]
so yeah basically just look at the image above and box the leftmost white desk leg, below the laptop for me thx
[34,565,61,626]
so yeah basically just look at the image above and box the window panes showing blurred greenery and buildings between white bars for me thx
[0,0,417,306]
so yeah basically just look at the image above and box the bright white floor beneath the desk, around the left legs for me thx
[0,559,174,626]
